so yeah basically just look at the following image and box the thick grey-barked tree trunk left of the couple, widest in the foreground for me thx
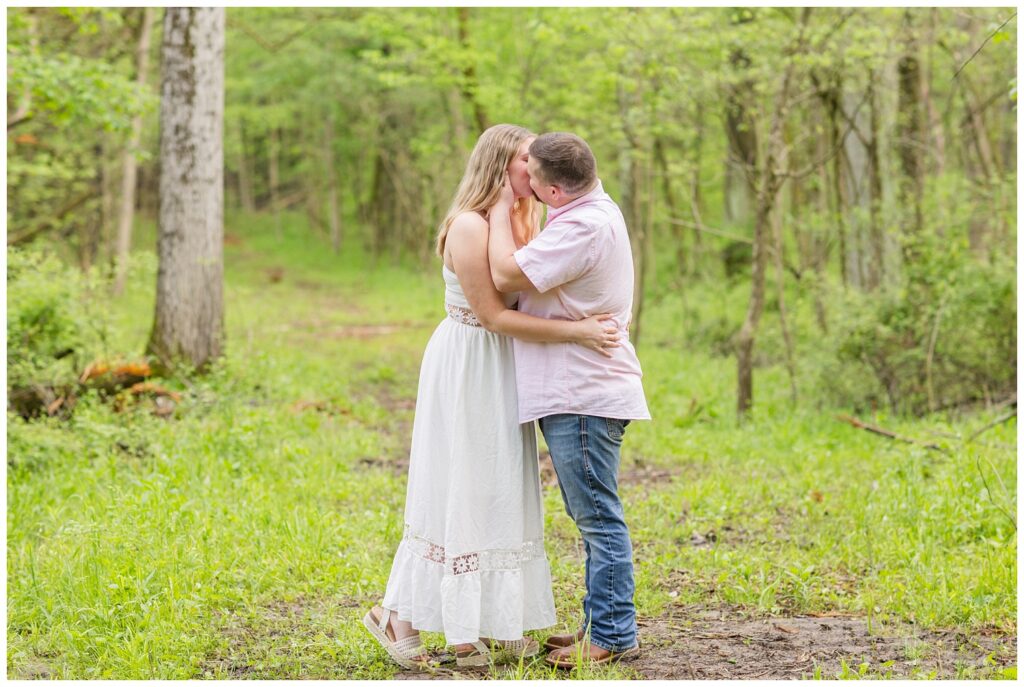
[147,7,224,370]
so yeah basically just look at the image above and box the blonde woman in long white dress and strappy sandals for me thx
[362,124,618,669]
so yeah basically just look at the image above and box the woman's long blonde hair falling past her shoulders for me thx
[437,124,541,258]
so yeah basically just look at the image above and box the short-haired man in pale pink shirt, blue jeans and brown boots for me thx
[487,133,650,668]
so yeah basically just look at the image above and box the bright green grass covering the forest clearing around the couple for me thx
[7,211,1017,679]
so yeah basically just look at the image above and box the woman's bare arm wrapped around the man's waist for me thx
[445,213,618,357]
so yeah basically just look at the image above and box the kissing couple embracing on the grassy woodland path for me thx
[362,124,650,670]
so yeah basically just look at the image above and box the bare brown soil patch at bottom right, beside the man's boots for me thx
[629,606,1017,680]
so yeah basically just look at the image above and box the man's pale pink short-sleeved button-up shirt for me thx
[514,181,650,423]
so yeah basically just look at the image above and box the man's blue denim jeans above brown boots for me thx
[540,415,637,652]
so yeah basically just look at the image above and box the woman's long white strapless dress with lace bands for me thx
[384,266,555,644]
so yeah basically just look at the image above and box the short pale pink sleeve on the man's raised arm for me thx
[513,221,597,294]
